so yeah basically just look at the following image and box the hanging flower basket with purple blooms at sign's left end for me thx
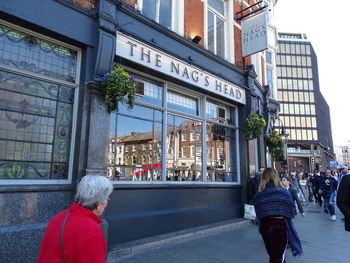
[102,67,137,112]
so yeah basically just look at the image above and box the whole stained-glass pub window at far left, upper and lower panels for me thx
[0,21,79,183]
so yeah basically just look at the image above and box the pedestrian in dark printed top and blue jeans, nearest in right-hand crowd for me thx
[319,170,338,221]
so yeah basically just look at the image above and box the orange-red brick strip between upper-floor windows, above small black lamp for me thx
[184,0,204,46]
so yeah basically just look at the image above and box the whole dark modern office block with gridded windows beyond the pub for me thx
[276,33,334,172]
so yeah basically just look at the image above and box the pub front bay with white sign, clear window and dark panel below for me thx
[88,32,246,248]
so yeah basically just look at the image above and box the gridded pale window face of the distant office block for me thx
[276,38,318,141]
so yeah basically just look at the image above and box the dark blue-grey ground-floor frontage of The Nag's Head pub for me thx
[0,0,278,262]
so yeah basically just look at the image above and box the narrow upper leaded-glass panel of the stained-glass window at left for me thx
[0,24,78,83]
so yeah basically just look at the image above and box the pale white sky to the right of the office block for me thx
[274,0,350,146]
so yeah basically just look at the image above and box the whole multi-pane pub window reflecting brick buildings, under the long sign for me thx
[106,71,239,183]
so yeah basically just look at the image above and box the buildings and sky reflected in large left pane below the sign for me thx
[107,105,162,181]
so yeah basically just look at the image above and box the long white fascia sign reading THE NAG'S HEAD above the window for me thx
[116,32,246,104]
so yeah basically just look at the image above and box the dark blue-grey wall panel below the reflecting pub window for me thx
[105,185,243,245]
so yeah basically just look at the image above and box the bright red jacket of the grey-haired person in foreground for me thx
[37,203,107,263]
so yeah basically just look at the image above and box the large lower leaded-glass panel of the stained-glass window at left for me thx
[0,71,74,179]
